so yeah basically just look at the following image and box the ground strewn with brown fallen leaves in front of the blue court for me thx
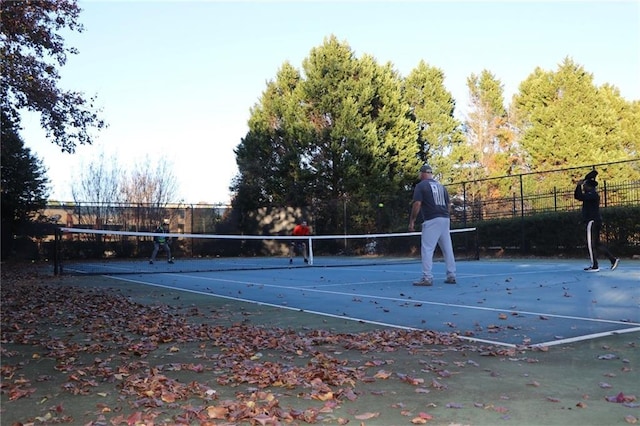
[0,264,640,425]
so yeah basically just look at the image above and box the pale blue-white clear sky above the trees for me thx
[21,1,640,203]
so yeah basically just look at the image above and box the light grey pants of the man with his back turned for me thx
[420,217,456,280]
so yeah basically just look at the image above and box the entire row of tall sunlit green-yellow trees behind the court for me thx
[225,36,640,238]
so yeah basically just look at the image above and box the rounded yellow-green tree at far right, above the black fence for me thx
[512,58,640,190]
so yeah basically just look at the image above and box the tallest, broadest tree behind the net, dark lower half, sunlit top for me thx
[232,37,452,233]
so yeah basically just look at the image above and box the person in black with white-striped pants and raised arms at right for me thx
[573,170,620,272]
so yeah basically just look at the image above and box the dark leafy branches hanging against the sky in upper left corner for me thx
[0,0,105,152]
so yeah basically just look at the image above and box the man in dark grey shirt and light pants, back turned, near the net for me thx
[409,164,456,286]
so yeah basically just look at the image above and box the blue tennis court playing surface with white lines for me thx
[71,257,640,346]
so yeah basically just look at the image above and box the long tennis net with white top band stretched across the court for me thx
[54,228,478,275]
